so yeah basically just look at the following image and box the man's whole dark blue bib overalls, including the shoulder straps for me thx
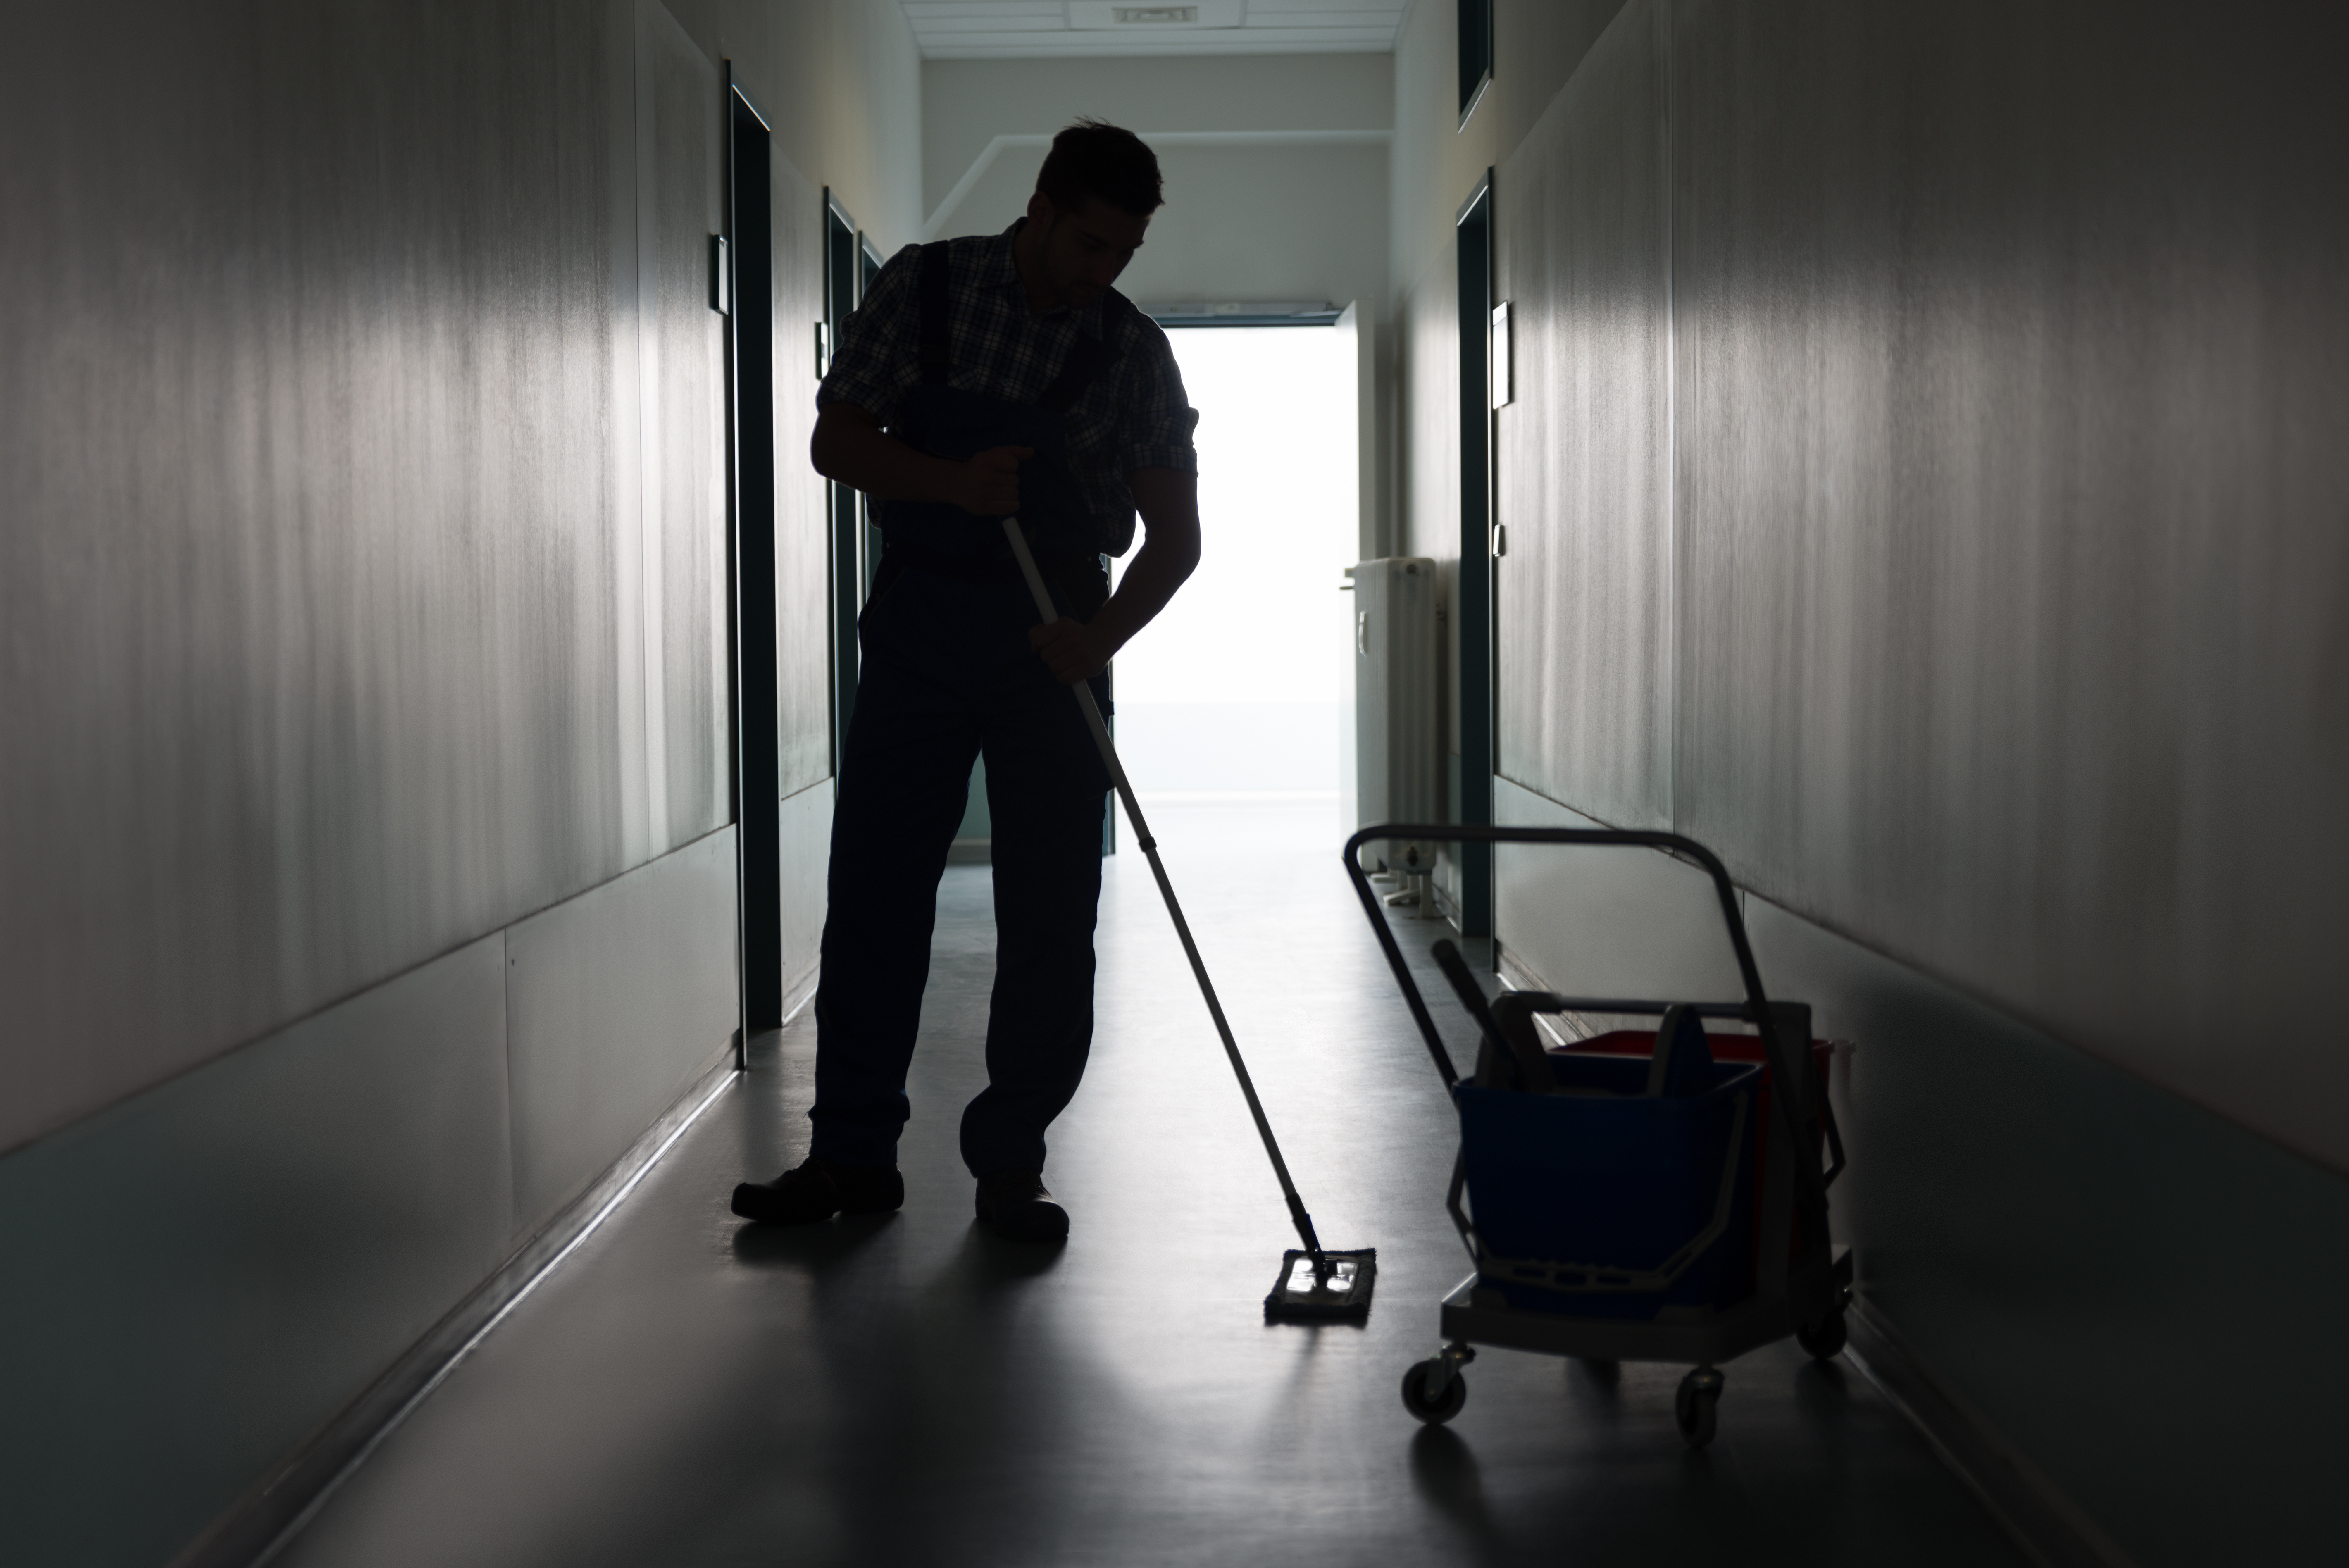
[808,245,1130,1175]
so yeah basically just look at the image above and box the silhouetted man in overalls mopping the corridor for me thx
[733,120,1198,1241]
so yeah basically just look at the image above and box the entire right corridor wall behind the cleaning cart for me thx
[1393,0,2349,1563]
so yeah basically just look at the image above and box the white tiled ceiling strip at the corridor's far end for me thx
[900,0,1412,59]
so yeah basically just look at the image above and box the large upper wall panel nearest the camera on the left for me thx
[0,5,629,1147]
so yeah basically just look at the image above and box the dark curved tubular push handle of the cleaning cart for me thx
[1341,823,1842,1258]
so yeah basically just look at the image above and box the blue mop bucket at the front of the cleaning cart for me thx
[1454,1053,1762,1319]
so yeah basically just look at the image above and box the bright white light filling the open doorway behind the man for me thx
[1116,327,1358,811]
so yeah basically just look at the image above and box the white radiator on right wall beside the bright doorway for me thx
[1348,555,1442,875]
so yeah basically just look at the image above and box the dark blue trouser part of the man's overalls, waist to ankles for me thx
[808,555,1109,1175]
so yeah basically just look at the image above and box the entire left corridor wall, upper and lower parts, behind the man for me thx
[0,0,918,1566]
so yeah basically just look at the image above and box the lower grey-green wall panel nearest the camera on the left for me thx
[0,936,512,1568]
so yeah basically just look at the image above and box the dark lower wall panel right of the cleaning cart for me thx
[1745,898,2349,1568]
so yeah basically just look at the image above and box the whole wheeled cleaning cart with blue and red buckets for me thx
[1346,825,1851,1448]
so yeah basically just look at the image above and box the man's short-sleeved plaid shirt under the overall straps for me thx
[815,219,1198,555]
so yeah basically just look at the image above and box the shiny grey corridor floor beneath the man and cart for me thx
[275,804,2023,1568]
